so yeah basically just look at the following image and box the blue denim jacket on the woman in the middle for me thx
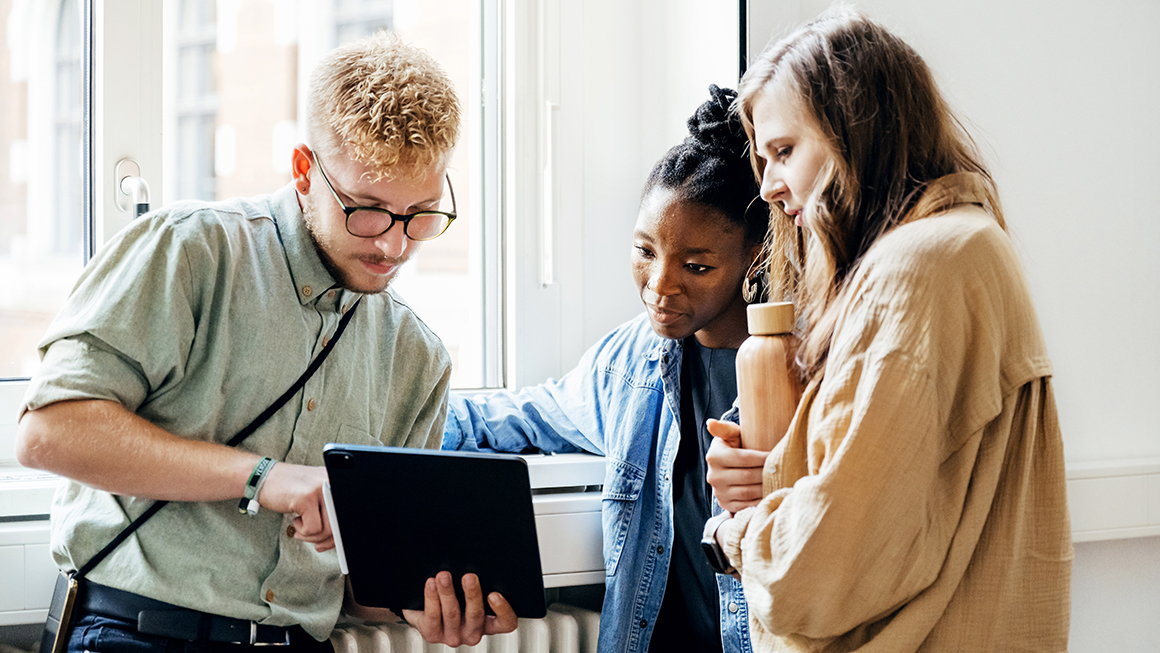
[443,314,752,653]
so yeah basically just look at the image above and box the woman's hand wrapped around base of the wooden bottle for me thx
[705,420,769,514]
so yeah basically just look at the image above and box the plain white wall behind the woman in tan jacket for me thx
[749,0,1160,653]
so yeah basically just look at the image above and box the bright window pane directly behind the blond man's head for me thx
[162,0,482,387]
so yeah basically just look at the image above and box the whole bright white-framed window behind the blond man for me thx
[0,0,563,465]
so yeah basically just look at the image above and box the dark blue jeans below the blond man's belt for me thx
[68,612,334,653]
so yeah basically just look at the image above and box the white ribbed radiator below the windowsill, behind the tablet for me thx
[331,603,600,653]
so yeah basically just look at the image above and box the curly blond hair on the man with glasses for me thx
[306,31,461,181]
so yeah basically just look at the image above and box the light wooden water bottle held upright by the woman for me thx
[737,302,802,451]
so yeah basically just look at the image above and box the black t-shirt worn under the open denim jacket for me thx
[648,336,737,653]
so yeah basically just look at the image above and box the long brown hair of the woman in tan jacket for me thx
[738,7,1003,378]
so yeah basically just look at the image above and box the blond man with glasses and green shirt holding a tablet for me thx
[17,34,516,652]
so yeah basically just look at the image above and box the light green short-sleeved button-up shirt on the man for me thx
[21,186,450,639]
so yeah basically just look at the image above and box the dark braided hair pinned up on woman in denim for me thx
[641,85,769,249]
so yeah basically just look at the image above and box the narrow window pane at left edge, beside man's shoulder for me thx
[0,0,87,378]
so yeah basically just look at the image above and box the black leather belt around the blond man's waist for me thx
[79,581,299,646]
